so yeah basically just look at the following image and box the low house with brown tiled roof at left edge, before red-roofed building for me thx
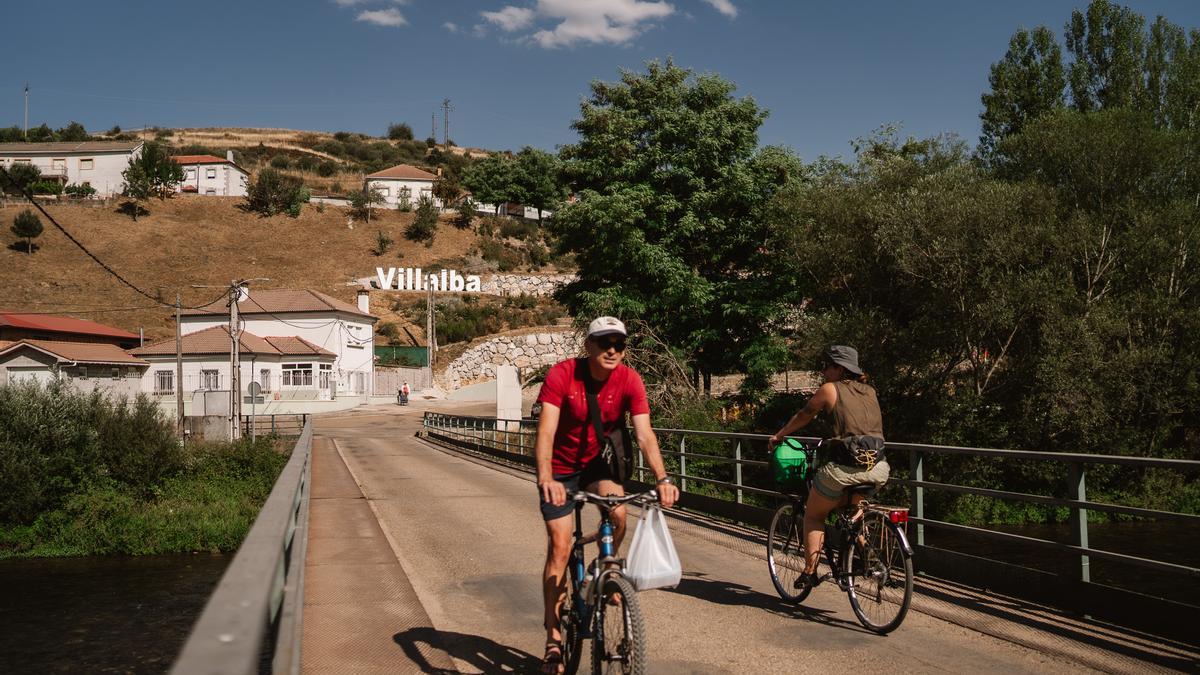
[0,336,148,396]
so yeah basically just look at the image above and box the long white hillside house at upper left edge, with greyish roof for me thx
[0,141,143,197]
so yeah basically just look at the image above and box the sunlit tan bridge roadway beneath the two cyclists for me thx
[301,401,1200,674]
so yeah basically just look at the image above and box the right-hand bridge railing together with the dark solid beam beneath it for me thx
[424,412,1200,634]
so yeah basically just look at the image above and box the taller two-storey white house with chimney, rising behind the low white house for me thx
[175,288,379,399]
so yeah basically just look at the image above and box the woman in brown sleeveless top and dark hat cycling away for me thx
[767,345,890,586]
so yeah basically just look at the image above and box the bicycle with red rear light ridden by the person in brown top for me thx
[767,448,912,635]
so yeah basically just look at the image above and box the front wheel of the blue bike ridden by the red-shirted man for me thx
[592,574,647,675]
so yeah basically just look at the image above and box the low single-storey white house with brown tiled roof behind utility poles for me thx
[130,325,337,414]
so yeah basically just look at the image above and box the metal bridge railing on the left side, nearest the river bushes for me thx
[172,419,312,675]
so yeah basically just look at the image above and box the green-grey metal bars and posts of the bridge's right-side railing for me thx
[424,412,1200,614]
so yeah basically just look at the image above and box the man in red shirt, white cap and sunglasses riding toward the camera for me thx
[535,316,679,673]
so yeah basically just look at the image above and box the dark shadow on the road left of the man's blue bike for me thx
[392,627,541,675]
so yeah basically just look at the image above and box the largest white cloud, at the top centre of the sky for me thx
[475,0,681,49]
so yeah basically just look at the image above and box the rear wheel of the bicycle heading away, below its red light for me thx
[845,512,912,635]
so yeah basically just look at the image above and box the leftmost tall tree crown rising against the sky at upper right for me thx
[979,26,1067,156]
